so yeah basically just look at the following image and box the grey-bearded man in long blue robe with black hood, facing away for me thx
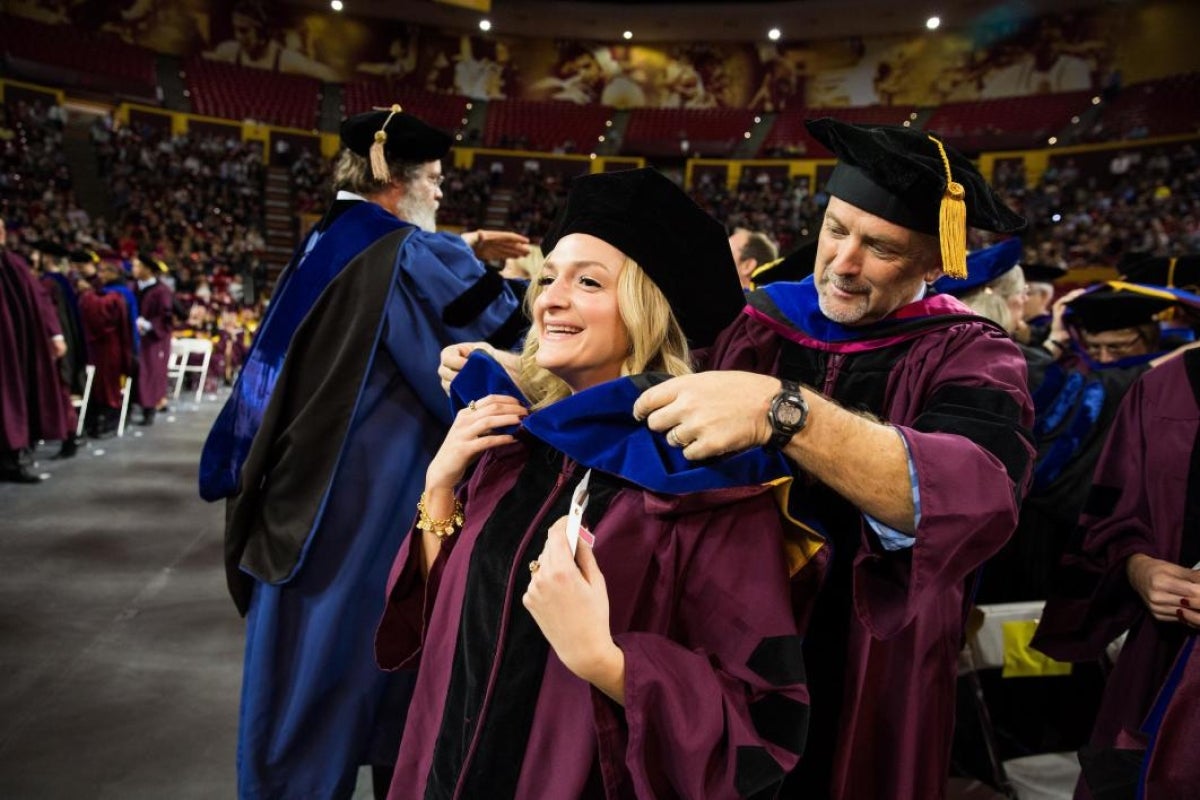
[214,106,526,800]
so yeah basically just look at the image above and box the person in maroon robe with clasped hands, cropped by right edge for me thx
[1033,349,1200,799]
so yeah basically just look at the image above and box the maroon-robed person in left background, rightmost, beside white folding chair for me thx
[133,253,175,425]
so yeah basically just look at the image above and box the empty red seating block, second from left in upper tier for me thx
[184,56,320,131]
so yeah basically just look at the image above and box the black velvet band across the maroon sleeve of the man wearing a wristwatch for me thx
[912,385,1032,483]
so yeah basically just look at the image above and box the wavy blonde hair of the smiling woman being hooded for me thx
[517,257,692,408]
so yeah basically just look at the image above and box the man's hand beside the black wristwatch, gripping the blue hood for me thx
[634,372,780,461]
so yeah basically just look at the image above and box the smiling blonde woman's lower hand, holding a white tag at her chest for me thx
[522,517,625,703]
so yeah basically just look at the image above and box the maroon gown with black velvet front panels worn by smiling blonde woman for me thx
[376,376,808,800]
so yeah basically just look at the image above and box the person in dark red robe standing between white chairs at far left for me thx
[79,254,134,438]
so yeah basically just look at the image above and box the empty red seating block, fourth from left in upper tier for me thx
[484,100,613,152]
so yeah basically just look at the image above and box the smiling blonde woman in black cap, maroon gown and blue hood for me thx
[376,169,808,800]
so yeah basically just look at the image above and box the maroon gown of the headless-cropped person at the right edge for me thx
[1033,350,1200,796]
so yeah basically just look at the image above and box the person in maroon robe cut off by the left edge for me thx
[0,219,74,483]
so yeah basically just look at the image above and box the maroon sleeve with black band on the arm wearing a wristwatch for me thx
[854,324,1034,638]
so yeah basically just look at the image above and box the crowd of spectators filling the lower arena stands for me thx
[0,95,1200,325]
